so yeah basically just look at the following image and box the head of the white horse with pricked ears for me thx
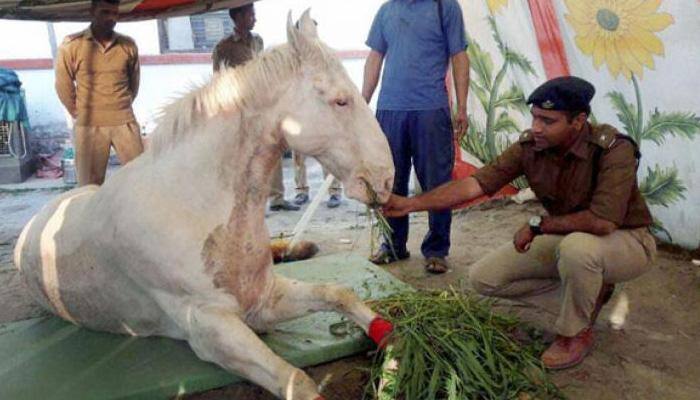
[278,10,394,203]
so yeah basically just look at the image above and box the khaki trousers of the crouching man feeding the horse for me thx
[469,228,656,336]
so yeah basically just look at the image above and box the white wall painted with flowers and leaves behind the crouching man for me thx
[460,0,700,248]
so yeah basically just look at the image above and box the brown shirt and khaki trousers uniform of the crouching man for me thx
[469,125,656,336]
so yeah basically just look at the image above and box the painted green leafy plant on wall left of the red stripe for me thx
[460,16,536,189]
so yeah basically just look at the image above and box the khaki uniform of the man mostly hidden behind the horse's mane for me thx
[212,32,284,206]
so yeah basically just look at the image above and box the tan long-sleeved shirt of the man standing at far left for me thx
[55,28,139,126]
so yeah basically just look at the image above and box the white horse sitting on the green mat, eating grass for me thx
[15,11,394,400]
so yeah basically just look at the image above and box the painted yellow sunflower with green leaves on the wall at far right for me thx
[564,0,700,241]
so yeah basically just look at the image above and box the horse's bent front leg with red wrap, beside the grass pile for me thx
[248,275,392,346]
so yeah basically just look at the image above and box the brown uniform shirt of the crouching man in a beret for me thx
[473,124,652,228]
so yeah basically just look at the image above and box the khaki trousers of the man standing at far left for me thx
[75,122,143,186]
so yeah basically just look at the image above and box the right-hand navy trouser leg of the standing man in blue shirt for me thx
[409,108,454,258]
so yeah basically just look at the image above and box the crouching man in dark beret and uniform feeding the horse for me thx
[385,77,656,369]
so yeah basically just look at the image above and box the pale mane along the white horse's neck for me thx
[151,45,301,154]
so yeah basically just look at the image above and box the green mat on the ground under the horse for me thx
[0,254,406,400]
